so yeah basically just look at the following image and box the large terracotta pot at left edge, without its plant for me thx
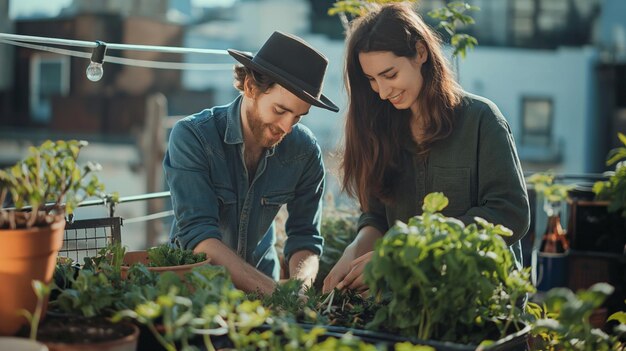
[0,219,65,335]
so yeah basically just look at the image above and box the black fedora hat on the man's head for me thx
[228,31,339,112]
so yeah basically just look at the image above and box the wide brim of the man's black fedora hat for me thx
[228,49,339,112]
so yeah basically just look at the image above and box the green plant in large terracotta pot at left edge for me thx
[0,140,104,335]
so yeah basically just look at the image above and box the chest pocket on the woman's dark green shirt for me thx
[432,167,471,216]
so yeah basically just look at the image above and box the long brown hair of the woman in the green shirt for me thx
[341,4,461,211]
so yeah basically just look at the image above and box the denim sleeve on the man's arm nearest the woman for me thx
[284,143,325,262]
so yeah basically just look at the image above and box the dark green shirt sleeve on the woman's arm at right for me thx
[459,106,530,245]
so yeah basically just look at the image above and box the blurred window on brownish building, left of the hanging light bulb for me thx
[30,53,70,123]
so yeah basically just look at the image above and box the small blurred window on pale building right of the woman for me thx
[522,97,554,146]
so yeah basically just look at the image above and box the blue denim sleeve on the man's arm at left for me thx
[163,119,222,249]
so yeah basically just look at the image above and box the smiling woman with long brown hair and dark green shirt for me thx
[323,4,530,292]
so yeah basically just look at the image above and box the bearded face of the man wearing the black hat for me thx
[246,84,311,148]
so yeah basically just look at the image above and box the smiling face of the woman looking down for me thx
[359,43,428,115]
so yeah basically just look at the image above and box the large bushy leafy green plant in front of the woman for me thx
[365,193,534,343]
